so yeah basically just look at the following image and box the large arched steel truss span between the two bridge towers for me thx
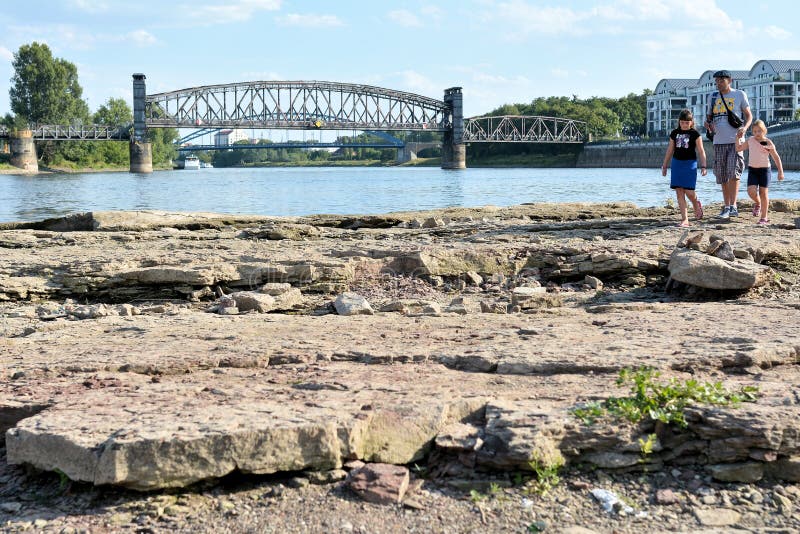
[144,81,453,132]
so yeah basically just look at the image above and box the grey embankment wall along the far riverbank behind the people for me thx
[576,132,800,170]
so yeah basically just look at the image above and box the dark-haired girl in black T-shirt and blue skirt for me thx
[661,109,707,228]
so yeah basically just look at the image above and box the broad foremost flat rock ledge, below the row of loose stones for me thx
[0,303,800,489]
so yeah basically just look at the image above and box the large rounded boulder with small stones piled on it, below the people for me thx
[668,249,772,290]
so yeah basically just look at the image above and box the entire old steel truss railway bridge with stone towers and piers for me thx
[0,73,584,173]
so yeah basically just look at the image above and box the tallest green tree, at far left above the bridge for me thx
[8,42,89,124]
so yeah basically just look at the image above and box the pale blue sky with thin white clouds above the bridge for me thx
[0,0,800,116]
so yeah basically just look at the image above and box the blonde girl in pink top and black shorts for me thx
[736,120,783,225]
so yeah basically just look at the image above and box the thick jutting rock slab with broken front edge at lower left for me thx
[6,364,494,489]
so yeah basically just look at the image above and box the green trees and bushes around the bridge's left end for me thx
[0,42,178,167]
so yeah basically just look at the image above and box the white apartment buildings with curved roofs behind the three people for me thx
[647,59,800,137]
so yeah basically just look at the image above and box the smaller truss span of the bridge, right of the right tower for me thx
[464,115,585,143]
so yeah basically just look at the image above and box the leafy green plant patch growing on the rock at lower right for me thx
[571,367,758,427]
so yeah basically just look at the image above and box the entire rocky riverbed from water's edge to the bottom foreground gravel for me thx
[0,200,800,532]
